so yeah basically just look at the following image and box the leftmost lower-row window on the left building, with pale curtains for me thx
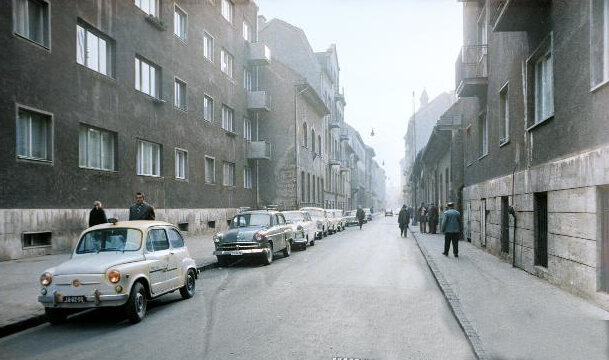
[17,109,53,161]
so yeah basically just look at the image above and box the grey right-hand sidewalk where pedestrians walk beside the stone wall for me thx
[408,227,609,360]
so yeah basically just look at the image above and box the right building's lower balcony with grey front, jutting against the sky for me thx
[455,45,488,97]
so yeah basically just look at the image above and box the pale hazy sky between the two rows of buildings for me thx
[254,0,462,200]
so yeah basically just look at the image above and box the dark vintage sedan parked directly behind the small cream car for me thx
[214,210,294,265]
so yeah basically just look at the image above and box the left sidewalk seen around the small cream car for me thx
[0,235,216,338]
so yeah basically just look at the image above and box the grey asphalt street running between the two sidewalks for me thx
[0,217,475,360]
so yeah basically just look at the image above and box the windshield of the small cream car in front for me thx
[76,228,142,254]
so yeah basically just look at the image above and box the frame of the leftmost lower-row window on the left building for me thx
[15,104,55,164]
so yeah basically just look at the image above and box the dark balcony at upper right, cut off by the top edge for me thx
[491,0,550,32]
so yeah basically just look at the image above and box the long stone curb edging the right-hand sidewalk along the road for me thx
[408,230,492,360]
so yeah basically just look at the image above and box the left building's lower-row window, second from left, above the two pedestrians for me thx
[78,125,116,171]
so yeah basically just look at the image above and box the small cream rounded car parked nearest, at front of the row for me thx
[38,221,198,325]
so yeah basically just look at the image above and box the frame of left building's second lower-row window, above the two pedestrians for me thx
[78,123,118,172]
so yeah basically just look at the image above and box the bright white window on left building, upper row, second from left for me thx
[76,24,114,76]
